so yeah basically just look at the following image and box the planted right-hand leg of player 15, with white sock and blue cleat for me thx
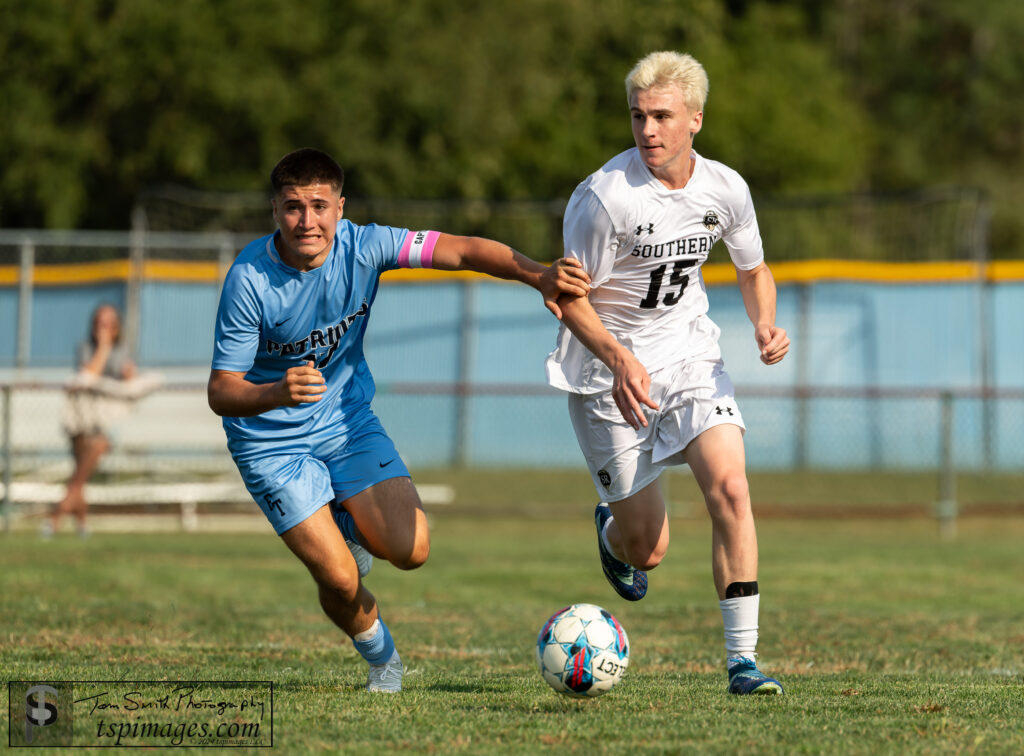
[684,424,782,695]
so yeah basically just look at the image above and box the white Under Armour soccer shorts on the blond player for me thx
[569,359,746,502]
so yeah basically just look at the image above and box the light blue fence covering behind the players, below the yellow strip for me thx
[0,277,1024,469]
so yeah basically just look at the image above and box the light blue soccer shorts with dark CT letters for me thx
[234,414,409,536]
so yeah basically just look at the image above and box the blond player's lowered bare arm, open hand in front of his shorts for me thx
[558,296,657,428]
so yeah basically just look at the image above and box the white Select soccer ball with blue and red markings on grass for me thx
[537,603,630,699]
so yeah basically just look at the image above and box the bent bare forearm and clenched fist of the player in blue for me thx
[206,363,327,417]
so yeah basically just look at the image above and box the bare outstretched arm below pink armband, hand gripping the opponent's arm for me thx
[432,234,590,319]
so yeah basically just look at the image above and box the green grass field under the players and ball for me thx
[0,475,1024,754]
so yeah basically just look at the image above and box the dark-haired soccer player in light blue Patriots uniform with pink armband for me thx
[208,150,587,692]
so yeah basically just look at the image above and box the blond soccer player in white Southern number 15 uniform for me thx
[547,52,790,694]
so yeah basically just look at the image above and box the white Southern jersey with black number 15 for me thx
[546,148,764,393]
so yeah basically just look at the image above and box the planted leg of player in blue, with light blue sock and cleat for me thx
[281,505,402,692]
